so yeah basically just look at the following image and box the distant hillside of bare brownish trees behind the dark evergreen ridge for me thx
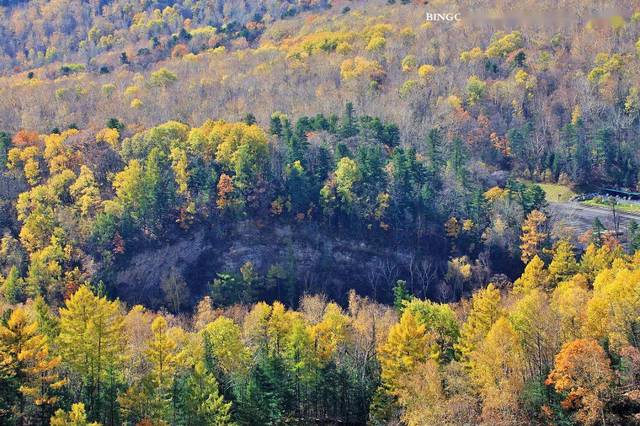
[0,0,640,191]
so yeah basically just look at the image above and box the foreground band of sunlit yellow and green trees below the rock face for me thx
[0,245,640,425]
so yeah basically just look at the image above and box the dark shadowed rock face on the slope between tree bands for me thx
[114,221,446,307]
